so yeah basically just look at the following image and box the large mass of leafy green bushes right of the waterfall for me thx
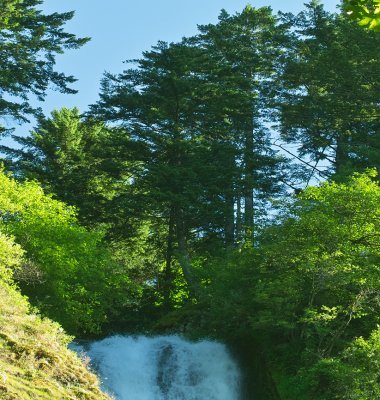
[194,170,380,400]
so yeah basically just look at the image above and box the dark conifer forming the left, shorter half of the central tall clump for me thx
[93,42,223,297]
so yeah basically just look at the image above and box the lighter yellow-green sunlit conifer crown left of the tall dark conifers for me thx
[3,108,128,226]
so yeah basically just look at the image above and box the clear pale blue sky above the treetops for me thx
[37,0,339,113]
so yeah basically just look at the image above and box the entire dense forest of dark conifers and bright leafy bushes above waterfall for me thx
[0,0,380,400]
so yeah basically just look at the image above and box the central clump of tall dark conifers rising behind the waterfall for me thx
[92,7,290,304]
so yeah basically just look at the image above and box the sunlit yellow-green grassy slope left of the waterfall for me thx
[0,279,110,400]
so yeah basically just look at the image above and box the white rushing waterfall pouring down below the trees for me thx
[76,336,240,400]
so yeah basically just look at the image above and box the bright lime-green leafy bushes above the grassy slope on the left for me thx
[0,169,141,333]
